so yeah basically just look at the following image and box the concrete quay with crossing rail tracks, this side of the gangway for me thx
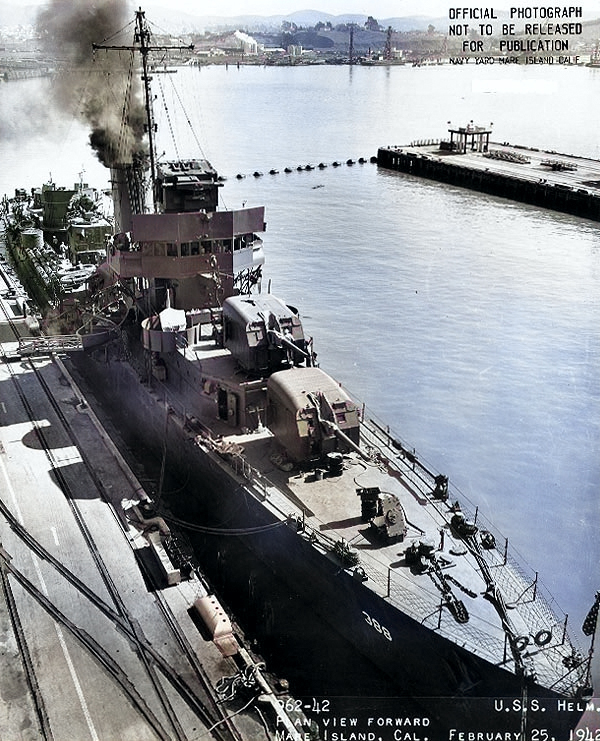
[0,342,308,741]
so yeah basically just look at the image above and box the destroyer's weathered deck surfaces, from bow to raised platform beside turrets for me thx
[175,343,574,693]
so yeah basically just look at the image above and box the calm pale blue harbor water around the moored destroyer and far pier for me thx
[0,65,600,676]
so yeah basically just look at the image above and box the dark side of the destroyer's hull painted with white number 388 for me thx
[73,344,585,741]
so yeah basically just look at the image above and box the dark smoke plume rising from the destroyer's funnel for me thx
[37,0,145,167]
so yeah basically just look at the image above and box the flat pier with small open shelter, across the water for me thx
[377,124,600,221]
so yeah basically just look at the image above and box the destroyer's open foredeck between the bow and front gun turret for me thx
[227,433,562,682]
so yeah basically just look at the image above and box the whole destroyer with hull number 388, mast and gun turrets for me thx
[1,10,592,740]
